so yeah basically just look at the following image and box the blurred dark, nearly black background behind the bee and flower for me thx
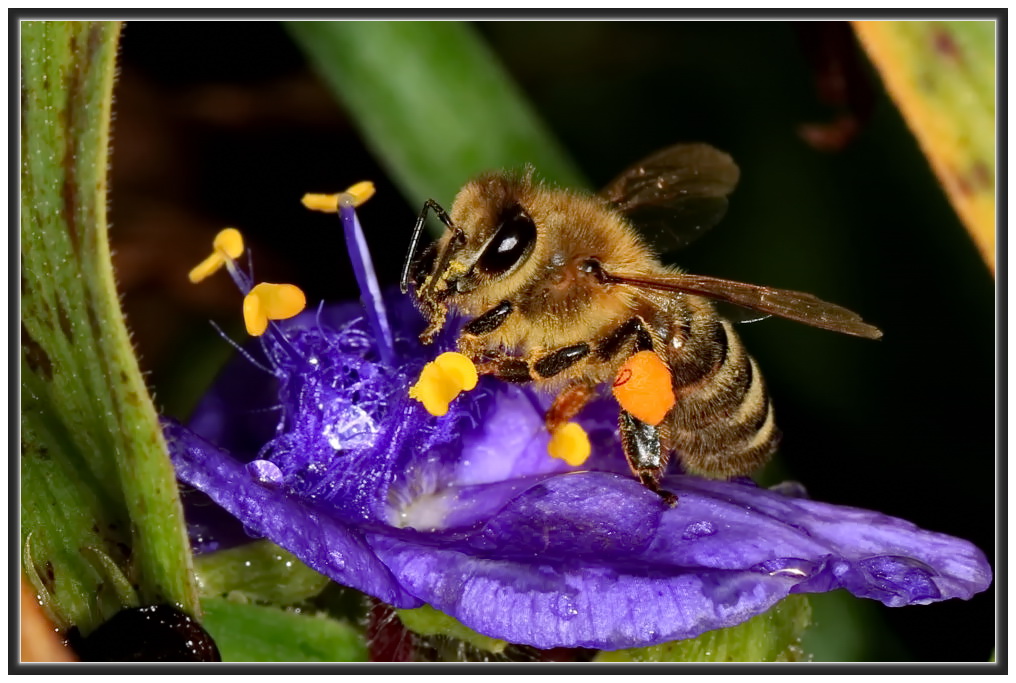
[112,21,997,662]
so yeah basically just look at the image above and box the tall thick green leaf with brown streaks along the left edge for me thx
[20,21,198,633]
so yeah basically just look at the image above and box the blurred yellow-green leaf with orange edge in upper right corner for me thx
[854,21,999,272]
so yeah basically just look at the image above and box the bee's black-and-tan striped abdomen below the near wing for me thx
[661,297,779,478]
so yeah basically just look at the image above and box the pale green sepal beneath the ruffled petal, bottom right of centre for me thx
[595,596,812,662]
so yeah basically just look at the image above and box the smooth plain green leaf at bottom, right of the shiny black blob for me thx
[201,598,367,662]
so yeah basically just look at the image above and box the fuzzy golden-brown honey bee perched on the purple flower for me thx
[401,143,882,503]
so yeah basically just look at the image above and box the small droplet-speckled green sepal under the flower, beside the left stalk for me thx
[194,541,329,605]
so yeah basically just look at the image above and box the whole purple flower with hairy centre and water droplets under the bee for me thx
[166,201,992,649]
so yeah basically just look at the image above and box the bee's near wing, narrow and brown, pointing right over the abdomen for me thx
[605,273,882,339]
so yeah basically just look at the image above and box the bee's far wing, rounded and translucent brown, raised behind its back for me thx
[600,143,741,254]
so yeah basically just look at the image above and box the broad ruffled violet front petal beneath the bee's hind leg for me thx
[368,473,991,648]
